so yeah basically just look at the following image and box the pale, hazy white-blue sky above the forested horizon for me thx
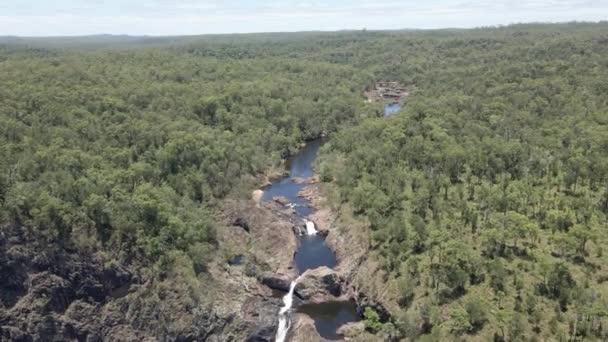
[0,0,608,36]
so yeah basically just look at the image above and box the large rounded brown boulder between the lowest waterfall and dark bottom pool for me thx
[295,266,343,303]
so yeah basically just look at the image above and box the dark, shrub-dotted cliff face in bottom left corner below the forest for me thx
[0,223,235,341]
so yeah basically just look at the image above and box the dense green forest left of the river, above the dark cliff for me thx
[0,39,372,269]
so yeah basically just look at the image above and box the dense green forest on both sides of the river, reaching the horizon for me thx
[0,23,608,341]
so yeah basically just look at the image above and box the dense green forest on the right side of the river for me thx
[320,25,608,341]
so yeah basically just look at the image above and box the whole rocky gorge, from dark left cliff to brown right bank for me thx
[0,140,382,341]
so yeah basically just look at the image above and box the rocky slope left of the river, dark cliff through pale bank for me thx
[0,196,304,341]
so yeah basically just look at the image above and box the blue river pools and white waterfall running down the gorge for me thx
[262,139,360,341]
